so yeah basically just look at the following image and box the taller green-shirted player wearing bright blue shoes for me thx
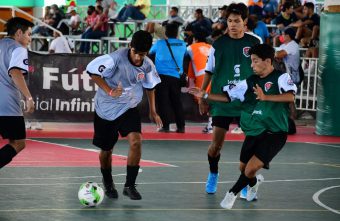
[199,3,259,197]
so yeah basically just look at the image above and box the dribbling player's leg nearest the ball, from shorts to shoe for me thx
[93,113,118,199]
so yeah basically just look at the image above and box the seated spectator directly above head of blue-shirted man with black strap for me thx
[145,7,184,39]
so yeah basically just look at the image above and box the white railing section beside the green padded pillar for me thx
[295,58,319,111]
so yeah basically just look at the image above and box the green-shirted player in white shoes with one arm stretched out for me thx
[189,44,297,209]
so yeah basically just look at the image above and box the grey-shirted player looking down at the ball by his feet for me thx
[86,31,162,200]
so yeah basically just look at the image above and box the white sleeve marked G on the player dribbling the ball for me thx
[86,55,117,78]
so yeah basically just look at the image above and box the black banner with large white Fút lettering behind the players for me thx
[22,52,207,122]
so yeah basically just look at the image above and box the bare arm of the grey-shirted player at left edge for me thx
[9,68,34,113]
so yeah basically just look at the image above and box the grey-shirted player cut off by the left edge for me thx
[0,17,34,168]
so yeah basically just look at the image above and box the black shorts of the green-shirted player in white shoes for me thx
[240,131,287,169]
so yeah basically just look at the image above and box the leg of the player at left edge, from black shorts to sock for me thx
[0,116,26,168]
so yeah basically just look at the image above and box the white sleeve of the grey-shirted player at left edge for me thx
[8,47,28,74]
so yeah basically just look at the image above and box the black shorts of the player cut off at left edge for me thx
[0,116,26,140]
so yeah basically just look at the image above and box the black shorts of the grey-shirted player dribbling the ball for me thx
[92,107,142,151]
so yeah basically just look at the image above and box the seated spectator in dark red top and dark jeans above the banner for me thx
[79,5,108,54]
